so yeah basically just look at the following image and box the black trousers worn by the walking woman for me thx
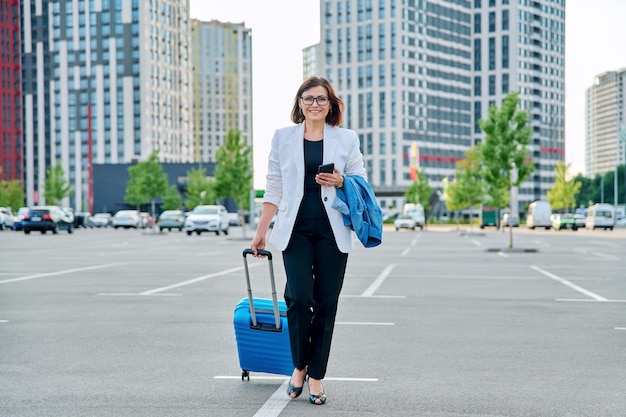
[283,217,348,379]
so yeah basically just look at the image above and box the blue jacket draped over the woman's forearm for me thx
[333,175,383,248]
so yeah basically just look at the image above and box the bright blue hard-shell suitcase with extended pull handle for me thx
[233,249,293,380]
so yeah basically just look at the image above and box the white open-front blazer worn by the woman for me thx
[263,123,366,253]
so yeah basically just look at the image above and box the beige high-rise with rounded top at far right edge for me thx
[585,68,626,178]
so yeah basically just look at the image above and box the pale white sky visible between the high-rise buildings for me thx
[190,0,626,188]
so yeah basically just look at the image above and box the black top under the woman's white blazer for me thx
[298,139,326,219]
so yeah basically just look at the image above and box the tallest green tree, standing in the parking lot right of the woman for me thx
[478,91,535,248]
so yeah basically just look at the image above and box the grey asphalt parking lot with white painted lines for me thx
[0,226,626,417]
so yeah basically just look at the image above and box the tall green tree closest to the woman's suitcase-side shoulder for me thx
[213,130,252,236]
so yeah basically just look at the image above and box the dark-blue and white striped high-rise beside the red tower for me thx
[20,0,192,210]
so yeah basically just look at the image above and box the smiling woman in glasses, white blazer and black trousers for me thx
[251,77,366,405]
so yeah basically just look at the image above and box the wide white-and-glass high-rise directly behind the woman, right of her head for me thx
[314,0,565,213]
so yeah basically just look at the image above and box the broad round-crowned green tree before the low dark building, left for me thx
[125,151,168,218]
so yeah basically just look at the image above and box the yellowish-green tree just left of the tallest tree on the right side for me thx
[446,147,485,228]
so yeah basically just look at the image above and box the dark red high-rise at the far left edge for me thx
[0,0,23,182]
